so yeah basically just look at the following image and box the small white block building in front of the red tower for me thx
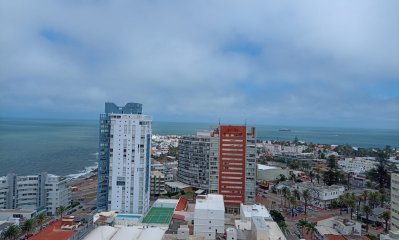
[194,194,224,240]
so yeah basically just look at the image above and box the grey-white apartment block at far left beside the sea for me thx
[0,173,71,215]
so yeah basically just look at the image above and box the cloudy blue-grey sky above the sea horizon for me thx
[0,0,399,129]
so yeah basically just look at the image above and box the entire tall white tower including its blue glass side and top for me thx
[97,103,152,214]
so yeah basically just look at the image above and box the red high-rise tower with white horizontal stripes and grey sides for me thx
[209,125,256,213]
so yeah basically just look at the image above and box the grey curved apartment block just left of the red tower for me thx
[177,133,210,190]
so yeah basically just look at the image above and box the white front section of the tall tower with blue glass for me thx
[108,114,151,213]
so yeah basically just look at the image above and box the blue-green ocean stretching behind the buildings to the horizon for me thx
[0,119,399,177]
